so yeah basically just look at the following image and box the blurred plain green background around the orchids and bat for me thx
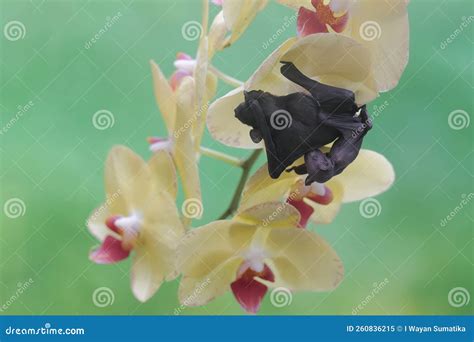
[0,0,474,315]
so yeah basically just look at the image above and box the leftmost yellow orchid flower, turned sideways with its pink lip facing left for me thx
[88,146,184,302]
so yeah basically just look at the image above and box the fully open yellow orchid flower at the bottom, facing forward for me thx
[178,203,344,313]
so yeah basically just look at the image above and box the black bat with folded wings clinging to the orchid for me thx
[234,62,372,185]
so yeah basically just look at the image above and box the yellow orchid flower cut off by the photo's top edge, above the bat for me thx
[279,0,409,92]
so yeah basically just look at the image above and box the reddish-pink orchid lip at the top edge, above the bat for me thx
[297,0,349,37]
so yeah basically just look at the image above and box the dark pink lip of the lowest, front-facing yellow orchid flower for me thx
[230,263,275,314]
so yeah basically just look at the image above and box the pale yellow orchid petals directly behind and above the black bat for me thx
[207,33,377,149]
